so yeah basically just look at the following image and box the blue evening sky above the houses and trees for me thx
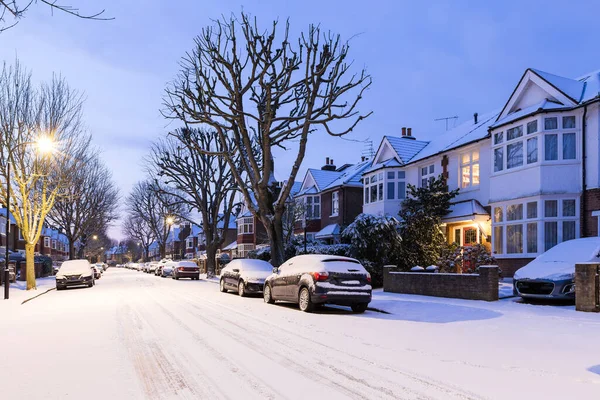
[0,0,600,241]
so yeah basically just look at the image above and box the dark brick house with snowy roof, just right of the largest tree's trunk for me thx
[294,157,371,244]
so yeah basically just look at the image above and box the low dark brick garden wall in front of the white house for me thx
[383,265,499,301]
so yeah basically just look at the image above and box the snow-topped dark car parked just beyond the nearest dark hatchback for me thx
[219,259,273,296]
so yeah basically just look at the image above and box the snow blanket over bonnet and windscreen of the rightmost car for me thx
[515,237,600,279]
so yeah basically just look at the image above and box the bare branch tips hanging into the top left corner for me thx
[0,0,114,33]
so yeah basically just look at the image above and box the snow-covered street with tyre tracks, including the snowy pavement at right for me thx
[0,268,600,400]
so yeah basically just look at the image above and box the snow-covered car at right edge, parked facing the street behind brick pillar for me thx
[513,237,600,299]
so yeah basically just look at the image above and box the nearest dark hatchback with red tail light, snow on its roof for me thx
[264,254,372,313]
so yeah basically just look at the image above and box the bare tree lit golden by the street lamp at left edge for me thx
[0,62,89,290]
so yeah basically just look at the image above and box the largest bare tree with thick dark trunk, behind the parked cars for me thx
[164,13,371,265]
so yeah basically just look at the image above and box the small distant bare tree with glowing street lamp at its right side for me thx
[126,181,188,258]
